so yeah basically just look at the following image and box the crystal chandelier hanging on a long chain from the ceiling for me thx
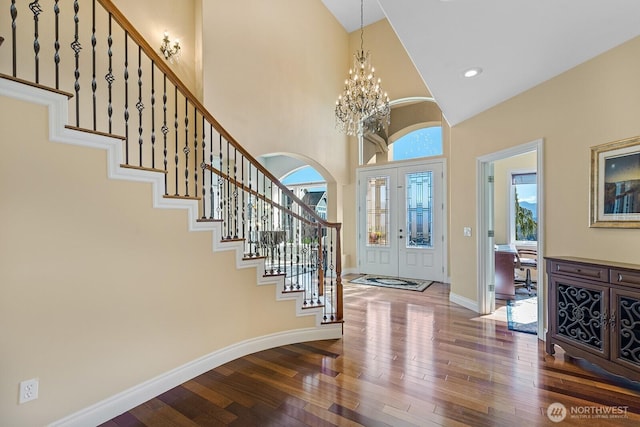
[336,0,391,135]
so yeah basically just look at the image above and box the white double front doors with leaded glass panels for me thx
[358,161,445,281]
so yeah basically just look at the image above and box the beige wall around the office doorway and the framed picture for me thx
[450,38,640,300]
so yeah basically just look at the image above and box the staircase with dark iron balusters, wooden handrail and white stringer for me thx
[0,0,342,425]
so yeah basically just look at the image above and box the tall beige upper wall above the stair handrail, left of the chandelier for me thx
[202,0,350,183]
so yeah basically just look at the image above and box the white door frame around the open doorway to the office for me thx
[476,139,547,339]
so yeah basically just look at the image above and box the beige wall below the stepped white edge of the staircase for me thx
[0,97,315,427]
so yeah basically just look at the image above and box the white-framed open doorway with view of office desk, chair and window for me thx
[477,140,544,337]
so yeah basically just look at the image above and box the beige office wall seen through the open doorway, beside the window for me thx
[493,151,537,244]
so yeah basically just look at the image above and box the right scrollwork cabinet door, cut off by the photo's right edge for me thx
[611,289,640,369]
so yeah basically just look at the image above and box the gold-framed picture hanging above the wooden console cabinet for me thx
[589,136,640,228]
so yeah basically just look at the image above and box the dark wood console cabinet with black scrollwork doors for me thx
[545,257,640,381]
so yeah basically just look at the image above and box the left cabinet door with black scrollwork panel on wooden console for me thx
[549,277,610,358]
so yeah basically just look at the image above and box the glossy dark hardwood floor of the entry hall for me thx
[103,283,640,427]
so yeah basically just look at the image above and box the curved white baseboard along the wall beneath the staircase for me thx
[49,324,342,427]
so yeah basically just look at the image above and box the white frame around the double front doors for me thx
[356,157,449,283]
